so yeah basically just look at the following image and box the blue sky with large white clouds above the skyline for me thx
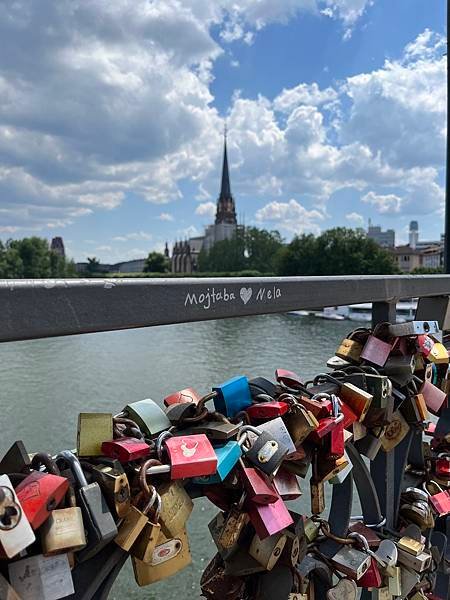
[0,0,446,263]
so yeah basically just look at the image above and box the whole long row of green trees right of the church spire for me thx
[198,227,398,275]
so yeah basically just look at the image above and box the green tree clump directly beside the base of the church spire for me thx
[198,227,283,274]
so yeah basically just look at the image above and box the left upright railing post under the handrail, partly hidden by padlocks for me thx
[370,300,400,528]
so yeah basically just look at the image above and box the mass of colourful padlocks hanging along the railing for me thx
[0,321,450,600]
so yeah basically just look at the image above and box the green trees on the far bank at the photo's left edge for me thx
[0,237,76,279]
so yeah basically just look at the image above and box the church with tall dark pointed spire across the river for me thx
[172,133,239,274]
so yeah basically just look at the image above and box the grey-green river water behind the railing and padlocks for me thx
[0,315,352,600]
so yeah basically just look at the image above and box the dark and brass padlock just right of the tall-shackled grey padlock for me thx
[83,463,131,519]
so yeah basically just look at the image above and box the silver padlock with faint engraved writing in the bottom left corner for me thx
[8,554,75,600]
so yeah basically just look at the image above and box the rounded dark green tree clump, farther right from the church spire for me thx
[277,227,398,275]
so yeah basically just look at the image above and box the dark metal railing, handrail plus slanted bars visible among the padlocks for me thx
[0,275,450,600]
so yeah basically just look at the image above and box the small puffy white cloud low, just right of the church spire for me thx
[255,199,324,234]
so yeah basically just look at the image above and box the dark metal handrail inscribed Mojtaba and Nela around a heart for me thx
[0,275,450,342]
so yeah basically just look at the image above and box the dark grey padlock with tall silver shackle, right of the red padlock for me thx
[57,450,117,562]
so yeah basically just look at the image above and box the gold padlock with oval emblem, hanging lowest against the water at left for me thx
[131,530,192,586]
